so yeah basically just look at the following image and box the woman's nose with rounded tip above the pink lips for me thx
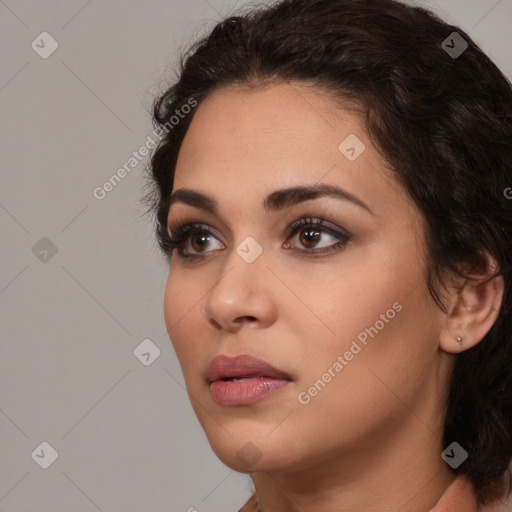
[203,250,279,332]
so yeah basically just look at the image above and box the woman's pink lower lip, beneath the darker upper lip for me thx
[210,377,290,405]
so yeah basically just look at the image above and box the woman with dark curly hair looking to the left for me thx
[142,0,512,512]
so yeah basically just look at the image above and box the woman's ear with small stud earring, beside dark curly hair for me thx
[439,256,505,353]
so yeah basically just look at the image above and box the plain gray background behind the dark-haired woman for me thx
[0,0,512,512]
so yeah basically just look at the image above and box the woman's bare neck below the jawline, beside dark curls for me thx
[252,417,455,512]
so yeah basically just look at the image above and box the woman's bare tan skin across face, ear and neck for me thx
[164,83,503,512]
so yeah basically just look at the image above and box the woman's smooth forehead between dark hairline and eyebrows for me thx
[174,83,412,220]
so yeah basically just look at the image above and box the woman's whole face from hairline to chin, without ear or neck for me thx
[165,84,449,472]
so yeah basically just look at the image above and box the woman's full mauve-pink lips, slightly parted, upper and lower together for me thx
[206,354,292,405]
